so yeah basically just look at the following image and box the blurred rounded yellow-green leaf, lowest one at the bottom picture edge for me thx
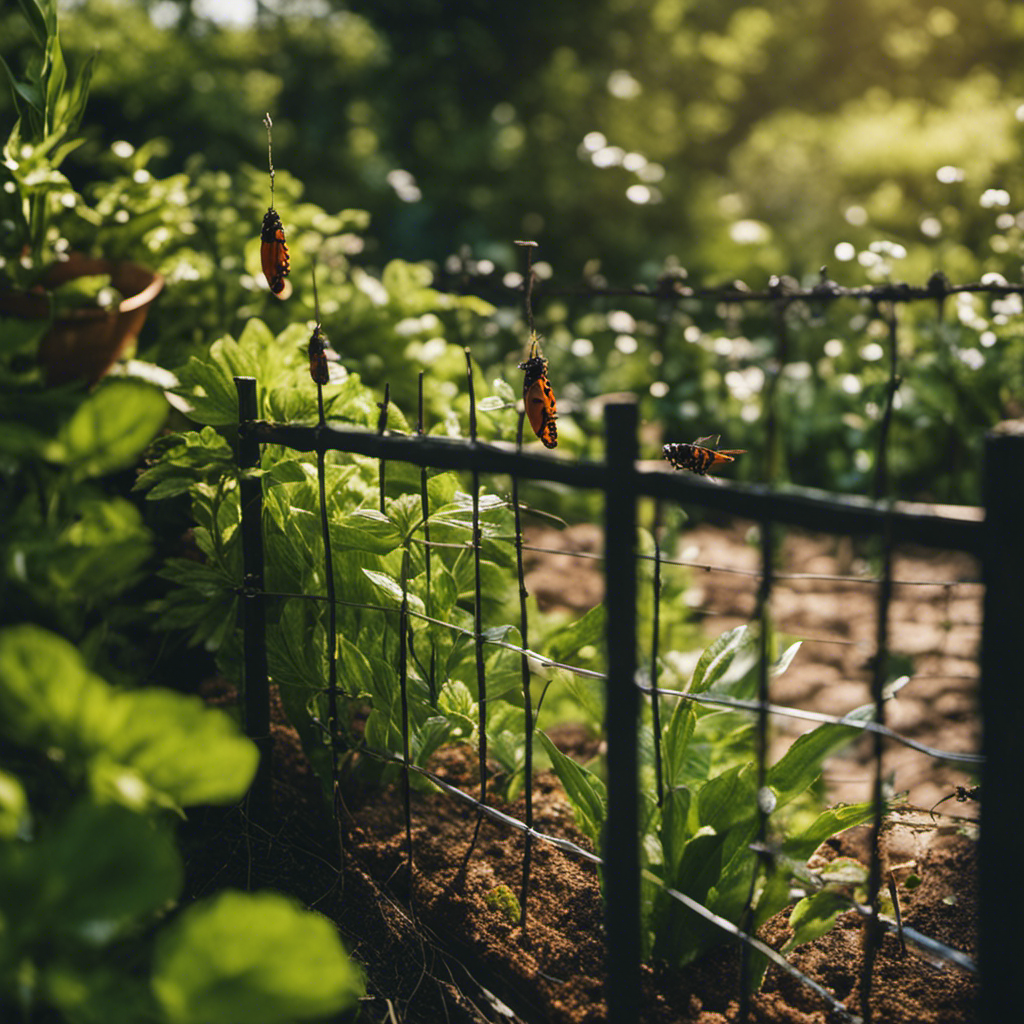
[153,892,364,1024]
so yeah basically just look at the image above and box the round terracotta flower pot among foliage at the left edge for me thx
[0,253,164,385]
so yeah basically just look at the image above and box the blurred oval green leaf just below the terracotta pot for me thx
[46,380,168,478]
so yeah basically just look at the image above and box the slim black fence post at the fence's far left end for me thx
[234,377,271,824]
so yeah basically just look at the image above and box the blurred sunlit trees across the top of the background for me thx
[0,0,1024,284]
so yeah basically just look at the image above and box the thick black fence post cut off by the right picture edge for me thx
[978,420,1024,1024]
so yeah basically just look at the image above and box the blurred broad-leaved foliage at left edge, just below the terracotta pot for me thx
[0,379,167,638]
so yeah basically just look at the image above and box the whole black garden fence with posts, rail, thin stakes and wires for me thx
[228,275,1024,1024]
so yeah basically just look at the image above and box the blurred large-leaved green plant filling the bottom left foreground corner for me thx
[0,626,361,1024]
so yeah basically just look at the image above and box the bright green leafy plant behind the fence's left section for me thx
[136,321,521,785]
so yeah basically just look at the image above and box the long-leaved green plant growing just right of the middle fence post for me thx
[538,626,873,967]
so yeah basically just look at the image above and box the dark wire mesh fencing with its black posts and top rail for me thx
[224,278,1024,1021]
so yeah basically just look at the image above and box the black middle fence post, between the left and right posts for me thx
[604,402,640,1024]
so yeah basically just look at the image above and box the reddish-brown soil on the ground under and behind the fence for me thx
[183,526,981,1024]
